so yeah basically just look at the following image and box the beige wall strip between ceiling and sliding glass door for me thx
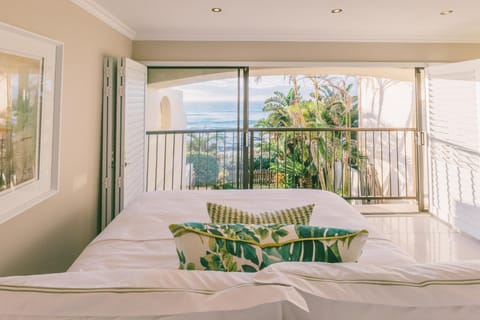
[133,41,480,63]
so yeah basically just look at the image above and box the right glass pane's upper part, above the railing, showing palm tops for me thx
[249,67,415,128]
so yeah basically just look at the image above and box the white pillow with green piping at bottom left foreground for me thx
[0,269,308,320]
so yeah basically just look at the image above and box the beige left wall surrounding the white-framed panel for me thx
[0,0,132,275]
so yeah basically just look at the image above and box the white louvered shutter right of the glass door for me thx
[427,60,480,239]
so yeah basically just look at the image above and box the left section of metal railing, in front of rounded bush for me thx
[146,129,244,191]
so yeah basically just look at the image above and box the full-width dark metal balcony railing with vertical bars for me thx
[146,128,417,201]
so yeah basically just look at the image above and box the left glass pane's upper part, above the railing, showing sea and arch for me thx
[147,68,248,130]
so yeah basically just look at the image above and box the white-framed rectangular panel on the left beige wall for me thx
[0,23,63,223]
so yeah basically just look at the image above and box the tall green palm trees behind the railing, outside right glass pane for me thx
[256,76,358,193]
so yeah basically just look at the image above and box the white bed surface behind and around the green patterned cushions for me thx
[69,189,415,271]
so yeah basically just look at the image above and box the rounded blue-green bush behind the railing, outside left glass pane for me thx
[186,153,219,187]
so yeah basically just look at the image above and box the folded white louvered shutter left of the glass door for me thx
[115,58,147,213]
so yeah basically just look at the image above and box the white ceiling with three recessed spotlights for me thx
[71,0,480,43]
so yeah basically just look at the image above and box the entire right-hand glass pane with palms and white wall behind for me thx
[249,67,415,201]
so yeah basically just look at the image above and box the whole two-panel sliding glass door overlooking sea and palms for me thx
[146,67,417,208]
